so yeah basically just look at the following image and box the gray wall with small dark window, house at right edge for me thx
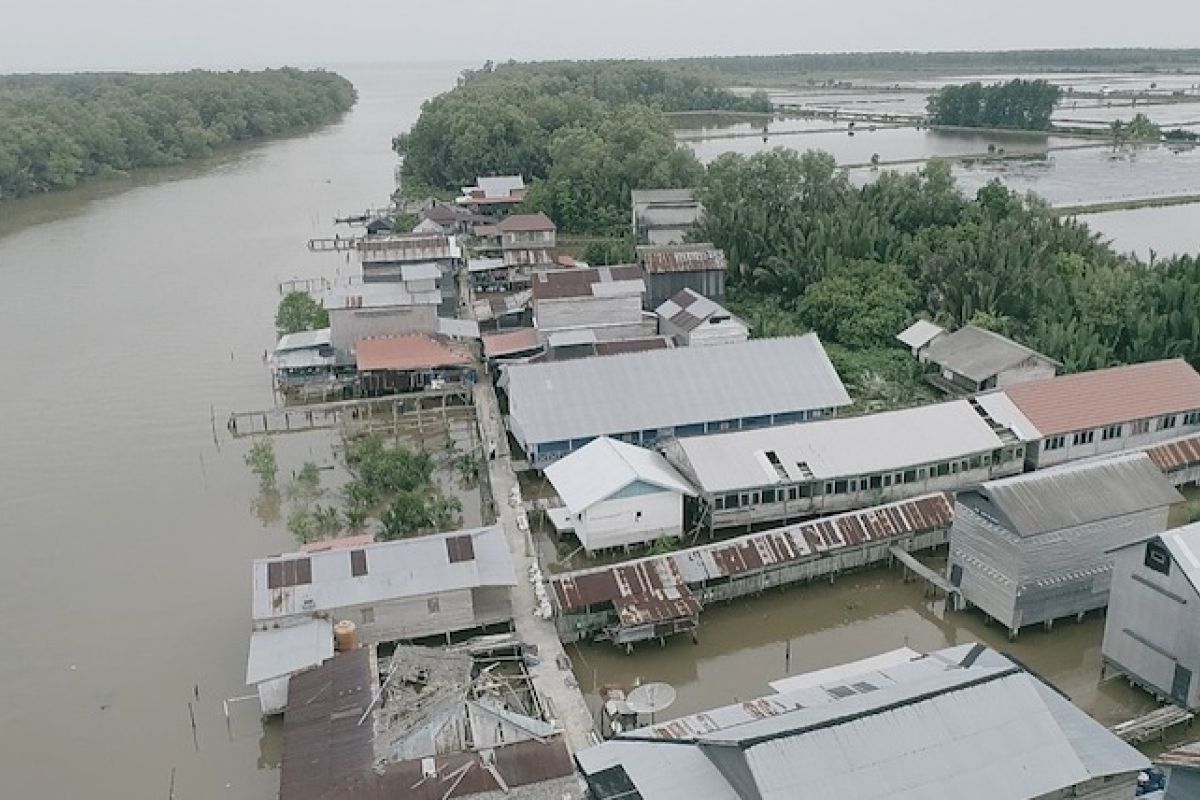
[1100,543,1200,710]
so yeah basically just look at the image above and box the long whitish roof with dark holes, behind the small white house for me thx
[671,400,1003,492]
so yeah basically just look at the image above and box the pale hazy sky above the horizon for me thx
[0,0,1200,72]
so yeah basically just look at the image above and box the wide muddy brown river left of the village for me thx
[0,66,461,800]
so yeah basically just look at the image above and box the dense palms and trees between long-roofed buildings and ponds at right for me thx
[695,149,1200,388]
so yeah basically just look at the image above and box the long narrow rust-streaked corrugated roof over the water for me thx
[552,494,954,622]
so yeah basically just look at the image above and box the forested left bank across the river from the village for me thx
[0,68,356,200]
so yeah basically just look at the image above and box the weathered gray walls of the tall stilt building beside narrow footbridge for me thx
[948,503,1168,633]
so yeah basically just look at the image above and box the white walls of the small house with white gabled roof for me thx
[575,492,683,553]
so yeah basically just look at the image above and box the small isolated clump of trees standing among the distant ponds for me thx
[929,79,1062,131]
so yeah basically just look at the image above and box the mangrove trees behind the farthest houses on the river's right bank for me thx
[394,61,770,233]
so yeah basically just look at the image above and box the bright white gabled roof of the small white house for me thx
[546,437,696,513]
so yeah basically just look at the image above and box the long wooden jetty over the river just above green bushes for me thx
[226,384,474,439]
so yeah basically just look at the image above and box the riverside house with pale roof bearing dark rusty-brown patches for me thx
[252,525,516,643]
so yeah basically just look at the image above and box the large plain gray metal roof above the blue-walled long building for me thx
[504,333,850,444]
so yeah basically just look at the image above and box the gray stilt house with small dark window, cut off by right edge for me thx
[1100,523,1200,712]
